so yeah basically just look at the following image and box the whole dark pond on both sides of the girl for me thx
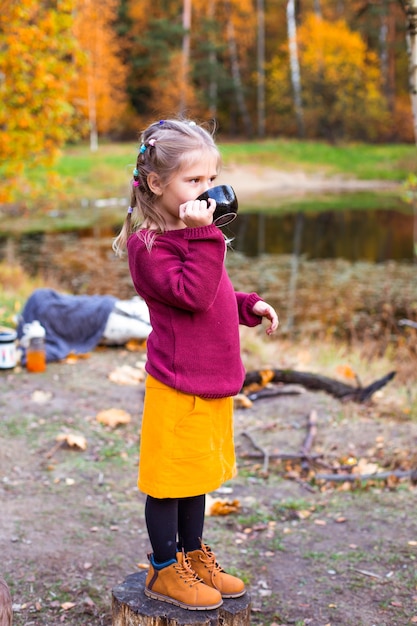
[0,200,417,275]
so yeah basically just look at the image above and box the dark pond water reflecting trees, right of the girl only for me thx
[226,210,414,263]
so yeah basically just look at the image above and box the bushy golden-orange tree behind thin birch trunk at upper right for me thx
[270,14,387,141]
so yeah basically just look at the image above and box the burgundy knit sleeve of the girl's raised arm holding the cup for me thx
[129,225,225,312]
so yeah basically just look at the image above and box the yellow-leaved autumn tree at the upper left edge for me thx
[0,0,78,202]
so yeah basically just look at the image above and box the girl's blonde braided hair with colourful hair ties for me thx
[112,120,221,256]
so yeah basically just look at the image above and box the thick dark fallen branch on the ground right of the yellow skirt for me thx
[243,369,396,403]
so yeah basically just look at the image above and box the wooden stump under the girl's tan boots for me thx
[112,572,250,626]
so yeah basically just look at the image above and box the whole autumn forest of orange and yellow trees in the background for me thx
[0,0,417,203]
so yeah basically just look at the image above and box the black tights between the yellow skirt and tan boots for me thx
[145,494,206,563]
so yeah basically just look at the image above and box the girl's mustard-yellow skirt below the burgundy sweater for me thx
[138,375,236,498]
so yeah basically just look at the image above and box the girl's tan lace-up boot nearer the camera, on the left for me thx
[145,552,223,611]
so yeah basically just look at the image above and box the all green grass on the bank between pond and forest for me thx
[0,138,417,234]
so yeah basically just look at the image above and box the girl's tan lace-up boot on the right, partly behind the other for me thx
[187,543,246,598]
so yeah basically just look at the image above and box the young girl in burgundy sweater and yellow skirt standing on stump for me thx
[114,120,278,610]
